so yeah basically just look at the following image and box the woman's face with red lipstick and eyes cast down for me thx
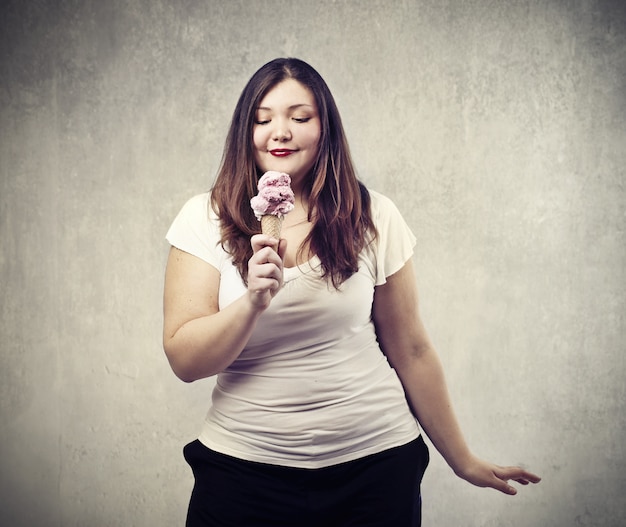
[252,79,321,188]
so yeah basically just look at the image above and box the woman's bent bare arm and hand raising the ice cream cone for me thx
[163,235,285,382]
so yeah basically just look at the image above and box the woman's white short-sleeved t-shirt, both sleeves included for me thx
[167,191,419,468]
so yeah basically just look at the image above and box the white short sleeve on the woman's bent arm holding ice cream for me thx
[165,193,226,269]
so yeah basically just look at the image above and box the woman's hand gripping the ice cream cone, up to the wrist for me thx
[248,234,287,310]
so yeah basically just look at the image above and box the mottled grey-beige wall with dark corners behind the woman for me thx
[0,0,626,527]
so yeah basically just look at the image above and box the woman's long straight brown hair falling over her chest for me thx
[211,58,376,288]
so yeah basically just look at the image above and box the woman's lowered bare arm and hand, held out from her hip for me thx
[373,262,540,494]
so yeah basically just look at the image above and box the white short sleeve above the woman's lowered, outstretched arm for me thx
[369,190,416,285]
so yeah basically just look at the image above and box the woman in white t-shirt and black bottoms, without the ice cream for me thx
[164,59,539,527]
